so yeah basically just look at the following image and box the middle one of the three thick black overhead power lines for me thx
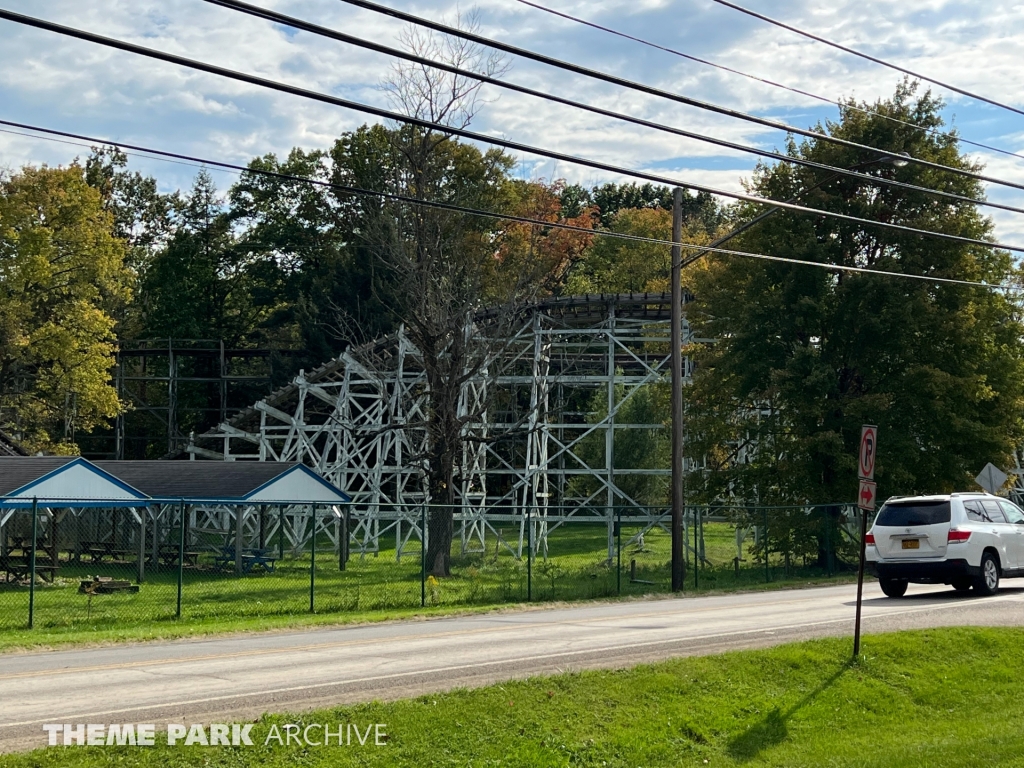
[197,0,1024,219]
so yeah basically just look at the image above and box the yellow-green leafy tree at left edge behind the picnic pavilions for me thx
[0,164,131,453]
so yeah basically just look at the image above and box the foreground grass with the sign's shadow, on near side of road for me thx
[0,628,1024,768]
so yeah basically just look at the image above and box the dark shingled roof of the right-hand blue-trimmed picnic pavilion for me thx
[93,461,298,500]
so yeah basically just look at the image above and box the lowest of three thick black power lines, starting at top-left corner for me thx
[6,9,1024,252]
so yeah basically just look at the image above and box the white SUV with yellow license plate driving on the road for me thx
[865,494,1024,597]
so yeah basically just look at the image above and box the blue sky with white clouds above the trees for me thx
[0,0,1024,245]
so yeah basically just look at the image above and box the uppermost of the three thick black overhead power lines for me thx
[325,0,1024,195]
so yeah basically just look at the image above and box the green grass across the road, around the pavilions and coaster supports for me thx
[0,523,850,652]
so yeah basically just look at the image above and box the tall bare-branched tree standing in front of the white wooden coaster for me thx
[339,14,557,575]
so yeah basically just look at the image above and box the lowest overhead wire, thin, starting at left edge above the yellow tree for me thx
[0,120,1007,292]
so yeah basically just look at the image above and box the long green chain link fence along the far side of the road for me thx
[0,504,859,632]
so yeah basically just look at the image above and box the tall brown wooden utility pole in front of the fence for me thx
[671,186,686,592]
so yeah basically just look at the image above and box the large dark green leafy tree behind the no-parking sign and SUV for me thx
[687,83,1024,518]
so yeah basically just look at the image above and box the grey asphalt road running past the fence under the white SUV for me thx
[0,581,1024,751]
